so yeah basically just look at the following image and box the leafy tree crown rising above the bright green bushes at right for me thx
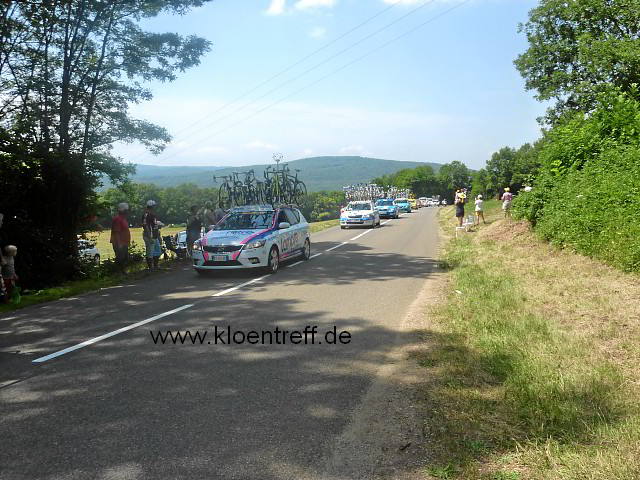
[514,0,640,124]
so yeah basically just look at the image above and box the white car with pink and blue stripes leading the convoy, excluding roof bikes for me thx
[191,205,311,275]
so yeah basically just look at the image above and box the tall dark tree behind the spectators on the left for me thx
[0,0,209,286]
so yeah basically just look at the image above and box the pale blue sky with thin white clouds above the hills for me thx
[114,0,545,168]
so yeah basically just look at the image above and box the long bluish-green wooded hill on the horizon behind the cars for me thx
[104,157,440,192]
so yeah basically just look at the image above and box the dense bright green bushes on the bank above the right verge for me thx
[514,87,640,271]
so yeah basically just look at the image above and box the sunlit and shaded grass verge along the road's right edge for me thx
[416,202,640,480]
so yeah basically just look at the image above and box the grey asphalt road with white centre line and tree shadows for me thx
[0,208,437,479]
